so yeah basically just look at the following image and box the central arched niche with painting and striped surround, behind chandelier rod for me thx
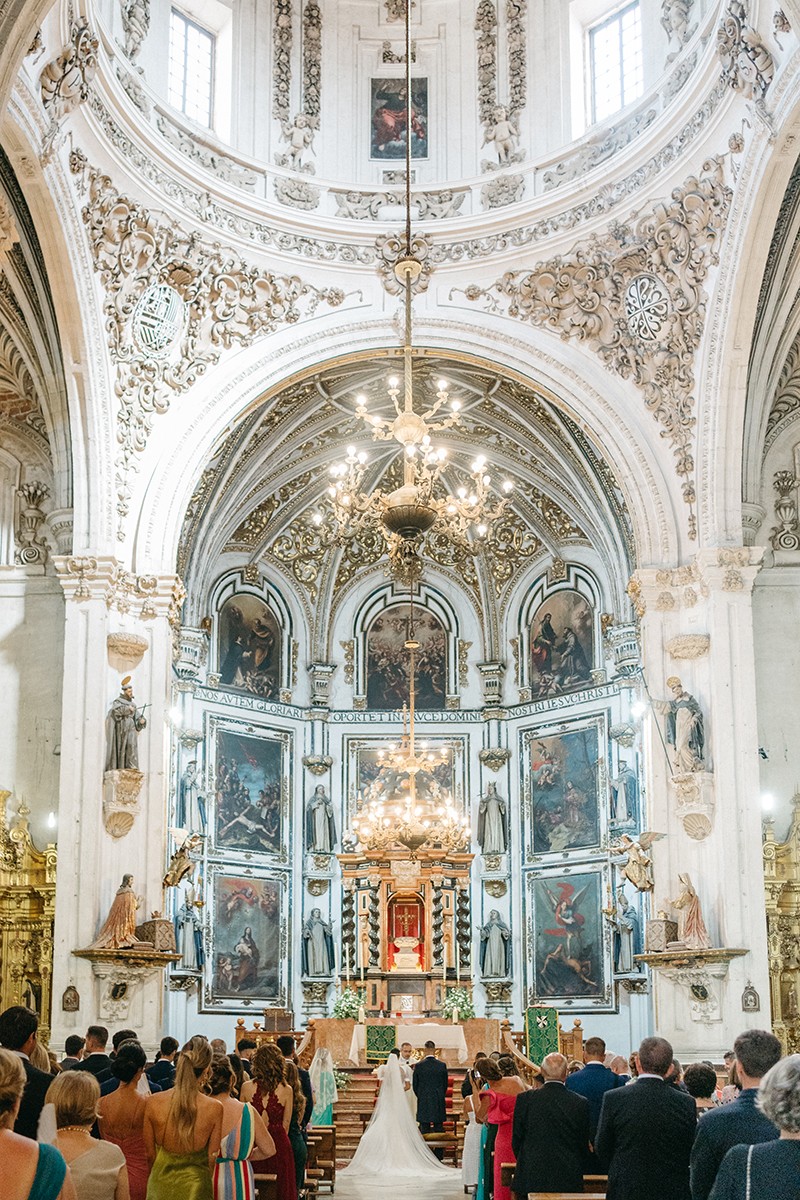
[354,584,459,712]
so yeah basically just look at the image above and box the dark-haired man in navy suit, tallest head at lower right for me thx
[691,1030,781,1200]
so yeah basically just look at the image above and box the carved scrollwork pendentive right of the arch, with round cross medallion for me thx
[465,158,732,538]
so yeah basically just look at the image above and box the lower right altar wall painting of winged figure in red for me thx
[530,871,606,1003]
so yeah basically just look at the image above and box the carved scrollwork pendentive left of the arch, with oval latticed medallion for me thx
[71,155,344,540]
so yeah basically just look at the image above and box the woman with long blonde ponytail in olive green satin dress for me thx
[143,1037,222,1200]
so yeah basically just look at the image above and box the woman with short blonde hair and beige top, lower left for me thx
[44,1070,131,1200]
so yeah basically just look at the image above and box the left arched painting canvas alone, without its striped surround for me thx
[219,592,281,700]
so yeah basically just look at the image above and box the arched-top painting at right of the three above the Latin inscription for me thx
[530,590,595,700]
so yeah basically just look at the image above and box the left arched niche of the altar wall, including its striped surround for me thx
[211,571,293,700]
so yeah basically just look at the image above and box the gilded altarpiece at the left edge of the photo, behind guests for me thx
[0,791,56,1042]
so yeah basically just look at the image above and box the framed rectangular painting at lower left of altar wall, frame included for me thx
[204,865,289,1012]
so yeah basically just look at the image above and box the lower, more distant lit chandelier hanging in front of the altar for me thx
[353,589,470,856]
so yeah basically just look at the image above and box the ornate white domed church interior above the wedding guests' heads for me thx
[0,0,800,1152]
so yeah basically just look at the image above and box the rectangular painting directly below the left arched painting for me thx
[213,728,284,854]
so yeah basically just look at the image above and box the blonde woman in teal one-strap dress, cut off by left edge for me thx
[0,1050,76,1200]
